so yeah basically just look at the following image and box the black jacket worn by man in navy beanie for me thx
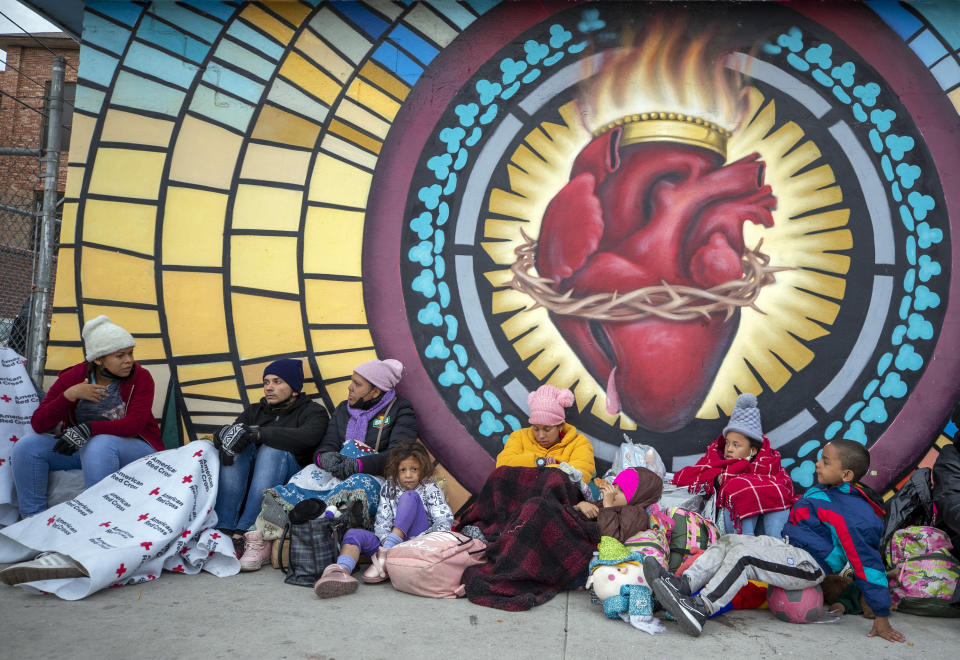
[237,394,330,467]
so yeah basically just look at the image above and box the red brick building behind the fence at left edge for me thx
[0,32,80,349]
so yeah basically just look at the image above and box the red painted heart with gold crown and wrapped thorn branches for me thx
[513,43,781,432]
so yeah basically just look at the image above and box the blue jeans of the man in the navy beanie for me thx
[214,445,300,529]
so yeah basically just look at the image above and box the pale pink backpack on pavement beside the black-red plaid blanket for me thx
[386,532,487,598]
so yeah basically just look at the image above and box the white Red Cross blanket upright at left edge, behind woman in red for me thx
[0,347,40,526]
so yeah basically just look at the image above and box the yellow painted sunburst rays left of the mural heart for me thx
[482,101,636,430]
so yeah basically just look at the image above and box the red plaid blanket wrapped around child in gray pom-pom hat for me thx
[673,435,797,532]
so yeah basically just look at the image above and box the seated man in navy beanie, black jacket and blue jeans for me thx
[213,359,330,571]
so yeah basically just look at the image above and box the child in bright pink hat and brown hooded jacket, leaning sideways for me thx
[574,468,663,543]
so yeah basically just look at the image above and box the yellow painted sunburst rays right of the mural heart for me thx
[697,88,853,419]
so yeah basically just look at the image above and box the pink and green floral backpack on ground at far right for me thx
[885,525,960,617]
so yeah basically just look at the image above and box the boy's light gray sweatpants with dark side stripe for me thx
[684,534,824,613]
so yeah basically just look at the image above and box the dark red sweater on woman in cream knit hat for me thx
[30,362,164,451]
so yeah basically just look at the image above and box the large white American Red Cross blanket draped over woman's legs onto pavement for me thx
[0,440,240,600]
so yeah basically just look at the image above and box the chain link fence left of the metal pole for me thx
[0,189,50,357]
